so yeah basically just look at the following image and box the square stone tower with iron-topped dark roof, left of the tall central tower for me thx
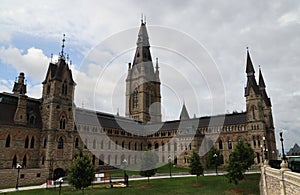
[41,36,76,172]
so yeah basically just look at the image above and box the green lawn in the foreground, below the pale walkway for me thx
[5,174,260,195]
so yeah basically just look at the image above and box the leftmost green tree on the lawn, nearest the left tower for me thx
[68,149,95,194]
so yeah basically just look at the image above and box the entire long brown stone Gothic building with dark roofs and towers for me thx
[0,21,277,185]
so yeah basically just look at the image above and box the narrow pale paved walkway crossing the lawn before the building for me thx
[0,171,260,193]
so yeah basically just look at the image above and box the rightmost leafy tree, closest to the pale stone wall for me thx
[226,141,254,184]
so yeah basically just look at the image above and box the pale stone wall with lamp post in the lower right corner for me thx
[260,162,300,195]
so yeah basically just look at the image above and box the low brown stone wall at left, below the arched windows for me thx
[0,169,49,188]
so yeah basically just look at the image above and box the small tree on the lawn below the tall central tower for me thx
[140,150,158,183]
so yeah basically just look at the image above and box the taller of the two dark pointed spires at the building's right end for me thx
[245,48,259,97]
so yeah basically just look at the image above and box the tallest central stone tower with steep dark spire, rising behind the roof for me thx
[125,19,161,123]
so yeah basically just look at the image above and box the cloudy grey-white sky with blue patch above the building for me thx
[0,0,300,149]
